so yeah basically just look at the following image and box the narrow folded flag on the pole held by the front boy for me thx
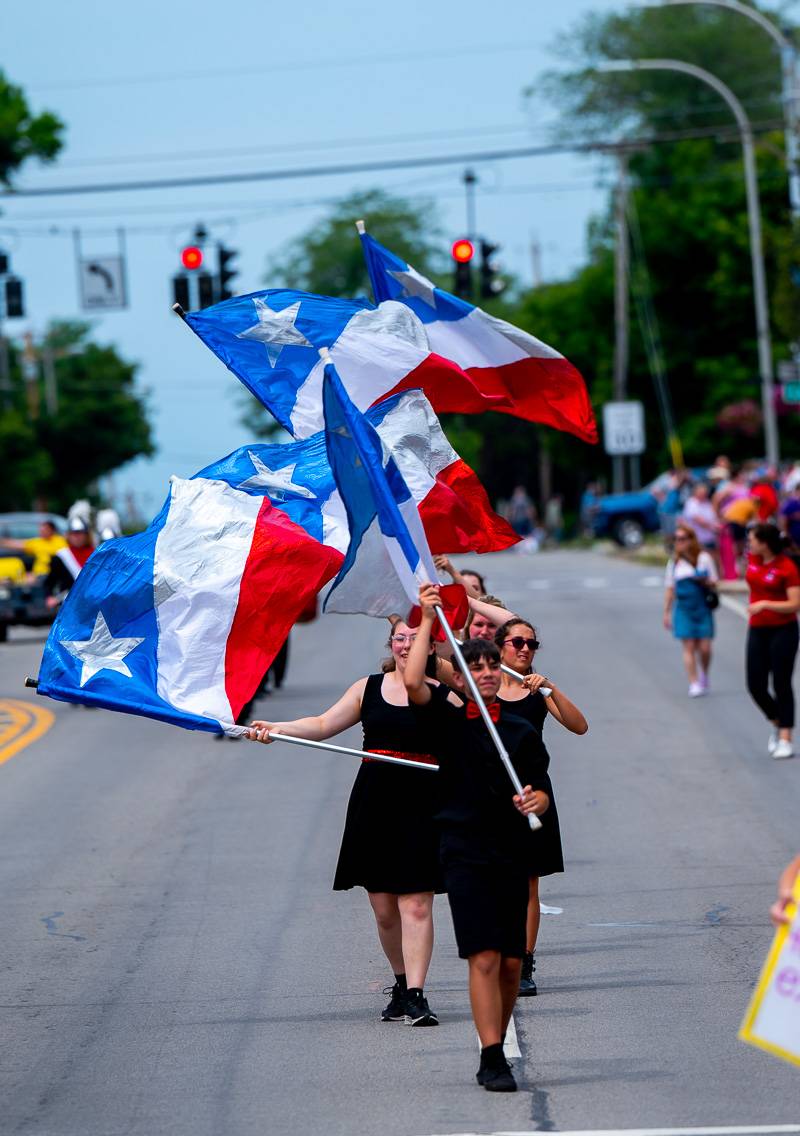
[323,362,438,616]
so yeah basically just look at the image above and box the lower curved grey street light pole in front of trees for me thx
[597,59,780,465]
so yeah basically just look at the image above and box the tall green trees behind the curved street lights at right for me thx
[520,6,800,483]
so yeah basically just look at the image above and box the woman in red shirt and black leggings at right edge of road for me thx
[744,525,800,758]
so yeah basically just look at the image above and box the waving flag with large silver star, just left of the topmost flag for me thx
[184,289,507,438]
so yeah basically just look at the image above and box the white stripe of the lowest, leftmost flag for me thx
[153,478,263,721]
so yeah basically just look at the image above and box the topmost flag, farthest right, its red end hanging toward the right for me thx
[361,233,598,442]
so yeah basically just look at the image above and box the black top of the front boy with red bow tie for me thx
[414,686,550,859]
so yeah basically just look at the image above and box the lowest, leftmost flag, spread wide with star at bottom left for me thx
[39,462,342,736]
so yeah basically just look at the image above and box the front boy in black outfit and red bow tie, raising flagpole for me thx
[403,584,550,1092]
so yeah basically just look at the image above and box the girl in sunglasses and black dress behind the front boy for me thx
[494,618,589,996]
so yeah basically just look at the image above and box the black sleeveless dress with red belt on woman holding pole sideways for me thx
[333,675,444,895]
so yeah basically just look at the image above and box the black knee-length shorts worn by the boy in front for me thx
[442,851,528,959]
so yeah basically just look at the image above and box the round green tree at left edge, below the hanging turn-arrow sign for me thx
[0,323,155,509]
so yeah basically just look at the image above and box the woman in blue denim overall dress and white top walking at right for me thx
[664,521,718,699]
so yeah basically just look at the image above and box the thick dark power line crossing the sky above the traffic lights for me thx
[0,123,781,200]
